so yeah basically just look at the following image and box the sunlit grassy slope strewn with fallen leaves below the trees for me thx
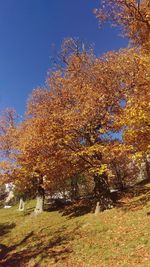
[0,185,150,267]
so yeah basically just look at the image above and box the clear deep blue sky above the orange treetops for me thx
[0,0,127,114]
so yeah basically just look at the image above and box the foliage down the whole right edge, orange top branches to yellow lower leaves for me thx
[95,0,150,180]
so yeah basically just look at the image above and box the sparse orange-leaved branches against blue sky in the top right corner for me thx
[95,0,150,50]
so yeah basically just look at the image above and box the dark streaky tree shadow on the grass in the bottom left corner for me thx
[0,229,72,267]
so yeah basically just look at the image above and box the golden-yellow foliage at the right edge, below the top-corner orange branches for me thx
[120,51,150,178]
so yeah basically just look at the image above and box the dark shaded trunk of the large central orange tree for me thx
[94,174,113,211]
